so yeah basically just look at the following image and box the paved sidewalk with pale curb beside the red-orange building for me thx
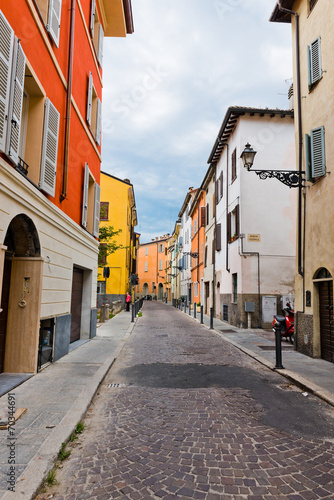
[0,311,135,500]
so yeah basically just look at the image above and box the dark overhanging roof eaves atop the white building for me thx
[207,106,294,164]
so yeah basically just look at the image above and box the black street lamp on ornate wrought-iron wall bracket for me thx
[240,143,305,187]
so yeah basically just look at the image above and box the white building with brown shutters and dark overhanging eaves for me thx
[208,107,297,328]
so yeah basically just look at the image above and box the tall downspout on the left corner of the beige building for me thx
[278,0,305,292]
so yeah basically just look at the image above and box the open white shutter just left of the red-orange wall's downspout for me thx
[39,99,59,196]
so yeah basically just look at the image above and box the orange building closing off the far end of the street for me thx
[135,234,169,300]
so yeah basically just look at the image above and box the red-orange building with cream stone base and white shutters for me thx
[0,0,133,373]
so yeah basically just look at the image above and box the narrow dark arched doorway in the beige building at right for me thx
[314,267,334,363]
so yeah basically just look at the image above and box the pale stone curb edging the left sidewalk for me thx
[0,318,137,500]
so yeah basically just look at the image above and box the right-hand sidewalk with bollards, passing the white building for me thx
[169,304,334,406]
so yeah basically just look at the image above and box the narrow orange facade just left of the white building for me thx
[189,189,206,304]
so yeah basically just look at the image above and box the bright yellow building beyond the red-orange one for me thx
[98,172,139,305]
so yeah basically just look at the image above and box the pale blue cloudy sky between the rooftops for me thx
[102,0,292,243]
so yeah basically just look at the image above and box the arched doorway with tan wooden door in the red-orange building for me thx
[0,214,43,373]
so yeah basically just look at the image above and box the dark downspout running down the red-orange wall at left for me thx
[59,0,76,202]
